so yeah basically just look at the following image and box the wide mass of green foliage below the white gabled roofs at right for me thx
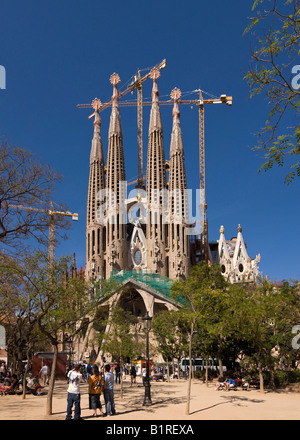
[168,263,300,383]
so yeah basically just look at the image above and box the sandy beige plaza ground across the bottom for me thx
[0,376,300,423]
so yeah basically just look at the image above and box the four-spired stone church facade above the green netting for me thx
[86,69,190,279]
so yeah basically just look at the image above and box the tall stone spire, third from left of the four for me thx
[146,69,168,275]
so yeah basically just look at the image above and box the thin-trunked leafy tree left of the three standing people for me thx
[0,252,110,415]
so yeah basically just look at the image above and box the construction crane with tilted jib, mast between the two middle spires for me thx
[77,59,167,189]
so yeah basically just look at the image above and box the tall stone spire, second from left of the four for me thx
[105,73,127,278]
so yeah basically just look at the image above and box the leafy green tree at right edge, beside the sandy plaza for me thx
[230,280,300,393]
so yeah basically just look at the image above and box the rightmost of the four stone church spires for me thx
[169,88,190,279]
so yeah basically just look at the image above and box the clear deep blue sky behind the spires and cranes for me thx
[0,0,300,280]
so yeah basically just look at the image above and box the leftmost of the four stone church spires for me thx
[86,99,105,278]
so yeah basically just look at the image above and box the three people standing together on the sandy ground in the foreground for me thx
[66,364,116,420]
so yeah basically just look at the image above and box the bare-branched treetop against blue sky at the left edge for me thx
[0,143,70,247]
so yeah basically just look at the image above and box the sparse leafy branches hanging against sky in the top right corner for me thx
[245,0,300,184]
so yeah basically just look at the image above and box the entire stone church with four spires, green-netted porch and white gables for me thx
[69,71,260,361]
